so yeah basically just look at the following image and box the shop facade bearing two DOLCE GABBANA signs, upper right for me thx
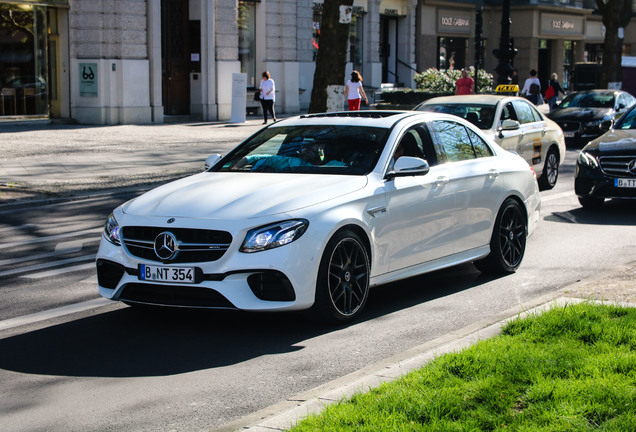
[416,0,636,92]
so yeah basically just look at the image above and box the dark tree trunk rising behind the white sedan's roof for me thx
[309,0,353,113]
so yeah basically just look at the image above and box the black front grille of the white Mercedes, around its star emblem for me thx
[122,226,232,264]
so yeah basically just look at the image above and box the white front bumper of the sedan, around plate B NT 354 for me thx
[96,218,321,311]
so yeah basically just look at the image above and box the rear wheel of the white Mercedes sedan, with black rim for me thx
[475,198,528,274]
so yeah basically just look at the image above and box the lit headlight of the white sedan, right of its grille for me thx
[240,219,309,253]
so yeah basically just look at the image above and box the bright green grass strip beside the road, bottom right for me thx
[291,302,636,432]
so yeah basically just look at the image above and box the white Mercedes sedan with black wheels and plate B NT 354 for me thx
[96,111,541,322]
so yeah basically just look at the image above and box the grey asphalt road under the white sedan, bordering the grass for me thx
[0,151,636,431]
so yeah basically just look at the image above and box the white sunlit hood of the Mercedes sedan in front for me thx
[123,172,367,219]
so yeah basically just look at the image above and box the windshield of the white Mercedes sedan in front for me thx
[215,125,389,175]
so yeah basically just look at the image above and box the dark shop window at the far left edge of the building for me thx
[0,3,48,116]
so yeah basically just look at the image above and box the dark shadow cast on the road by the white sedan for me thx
[0,264,492,377]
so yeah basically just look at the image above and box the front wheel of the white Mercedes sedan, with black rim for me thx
[313,230,371,323]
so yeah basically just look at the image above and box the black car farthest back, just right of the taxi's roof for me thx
[548,90,636,145]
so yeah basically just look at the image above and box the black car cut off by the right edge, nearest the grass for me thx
[574,106,636,207]
